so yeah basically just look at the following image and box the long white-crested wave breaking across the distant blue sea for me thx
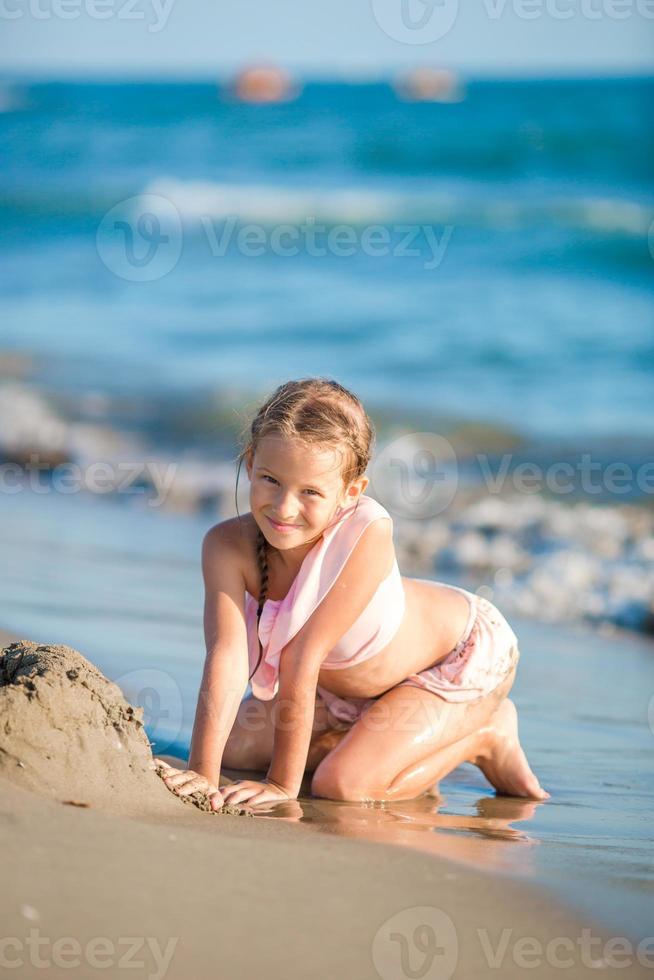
[0,176,654,242]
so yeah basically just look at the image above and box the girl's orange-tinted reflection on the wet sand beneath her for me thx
[223,769,542,875]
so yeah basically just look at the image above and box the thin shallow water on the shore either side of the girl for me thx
[0,491,654,939]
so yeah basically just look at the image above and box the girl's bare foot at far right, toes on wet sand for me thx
[472,698,550,800]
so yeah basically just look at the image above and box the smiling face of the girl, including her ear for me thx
[246,434,368,550]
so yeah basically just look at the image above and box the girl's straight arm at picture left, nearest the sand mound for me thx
[188,521,254,786]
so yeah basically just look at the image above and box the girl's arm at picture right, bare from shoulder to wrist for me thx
[268,518,395,795]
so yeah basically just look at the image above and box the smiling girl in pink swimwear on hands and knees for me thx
[157,378,549,809]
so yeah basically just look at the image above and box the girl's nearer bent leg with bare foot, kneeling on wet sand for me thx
[311,668,547,801]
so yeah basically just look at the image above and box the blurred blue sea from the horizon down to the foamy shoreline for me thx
[0,79,654,441]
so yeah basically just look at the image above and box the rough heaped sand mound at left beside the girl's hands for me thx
[0,640,246,814]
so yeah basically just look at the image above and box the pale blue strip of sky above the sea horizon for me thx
[0,0,654,77]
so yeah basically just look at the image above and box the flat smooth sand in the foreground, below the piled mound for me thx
[6,779,651,980]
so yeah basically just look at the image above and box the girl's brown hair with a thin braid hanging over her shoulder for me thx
[235,377,375,680]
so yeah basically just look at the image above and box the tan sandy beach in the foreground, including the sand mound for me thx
[0,635,653,980]
